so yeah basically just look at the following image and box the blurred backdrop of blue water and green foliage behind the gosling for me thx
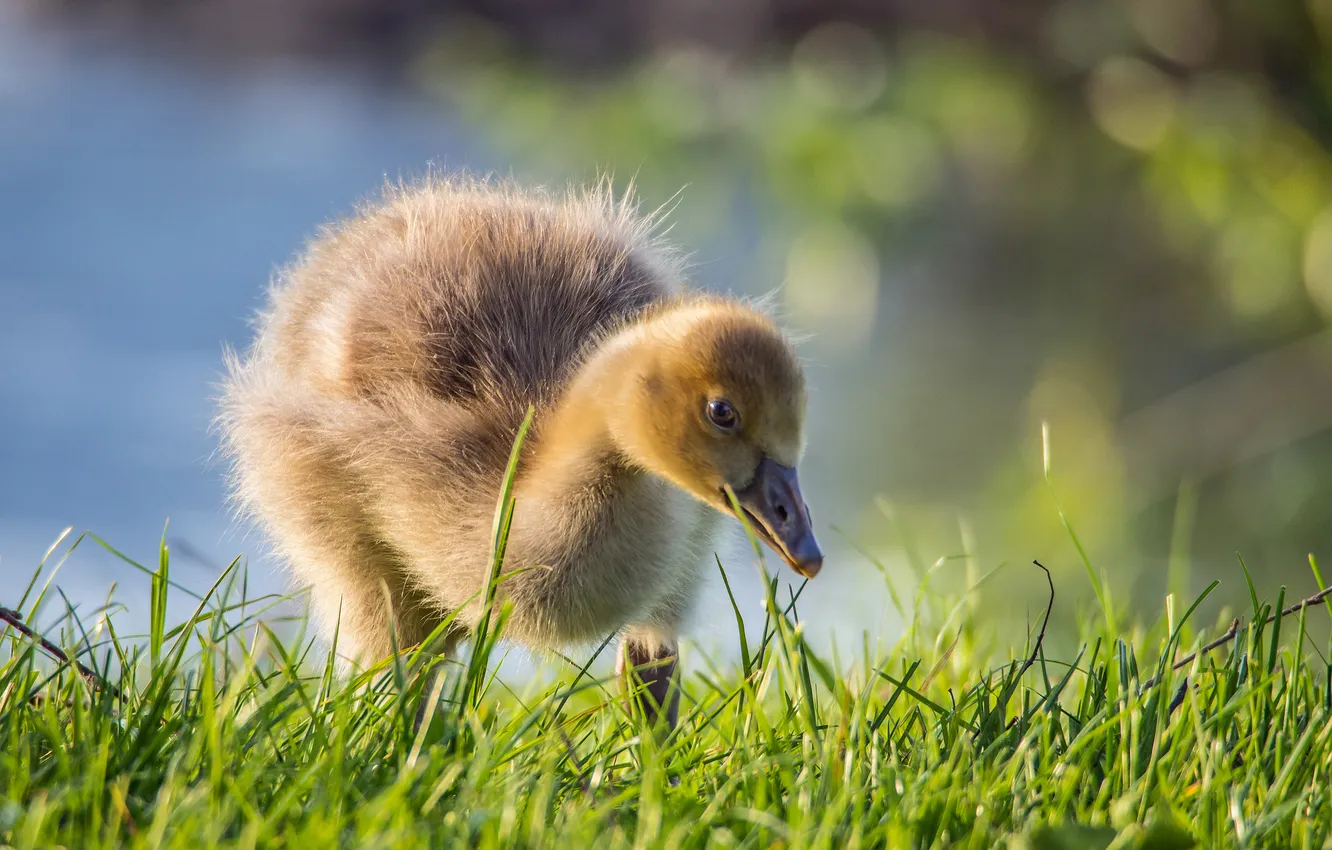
[0,0,1332,663]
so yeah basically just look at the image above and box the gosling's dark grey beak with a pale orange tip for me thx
[735,457,823,578]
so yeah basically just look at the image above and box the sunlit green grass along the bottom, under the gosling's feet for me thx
[0,516,1332,850]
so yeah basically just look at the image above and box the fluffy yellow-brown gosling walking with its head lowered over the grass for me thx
[220,177,823,725]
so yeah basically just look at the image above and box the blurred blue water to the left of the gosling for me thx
[0,24,492,626]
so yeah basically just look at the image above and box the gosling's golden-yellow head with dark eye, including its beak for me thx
[617,301,823,577]
